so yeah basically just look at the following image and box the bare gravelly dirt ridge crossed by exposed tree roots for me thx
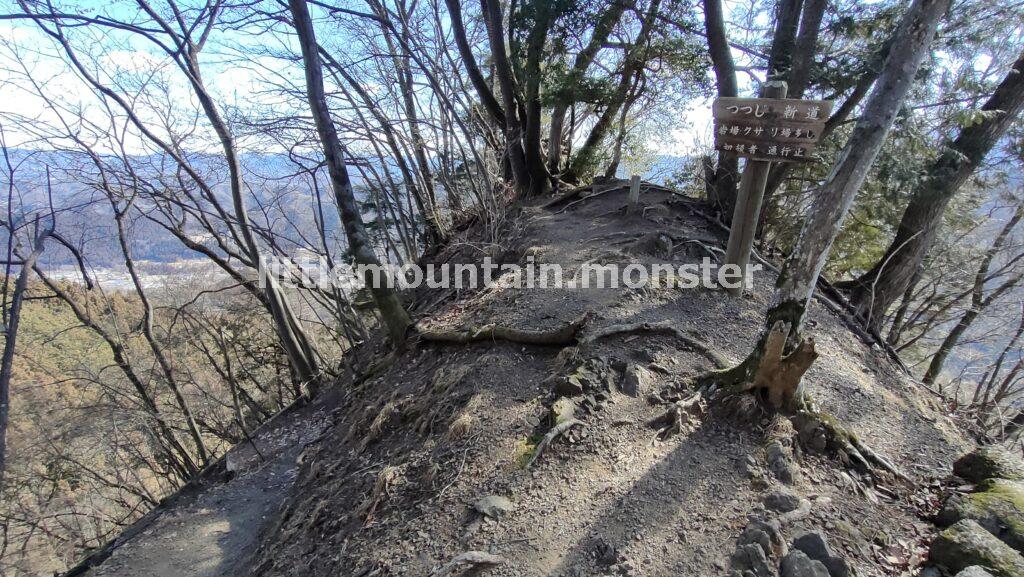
[243,190,970,577]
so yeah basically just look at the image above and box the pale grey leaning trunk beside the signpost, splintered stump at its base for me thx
[712,0,951,409]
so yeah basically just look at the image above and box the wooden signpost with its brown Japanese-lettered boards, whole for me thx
[713,82,833,296]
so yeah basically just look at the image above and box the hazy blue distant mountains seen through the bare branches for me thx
[0,150,688,269]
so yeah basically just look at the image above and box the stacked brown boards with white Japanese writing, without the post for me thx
[712,97,833,162]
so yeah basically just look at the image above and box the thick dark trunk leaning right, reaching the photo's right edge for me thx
[843,54,1024,330]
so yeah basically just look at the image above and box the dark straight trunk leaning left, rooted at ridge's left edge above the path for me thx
[289,0,413,344]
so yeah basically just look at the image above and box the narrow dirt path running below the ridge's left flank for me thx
[85,407,325,577]
